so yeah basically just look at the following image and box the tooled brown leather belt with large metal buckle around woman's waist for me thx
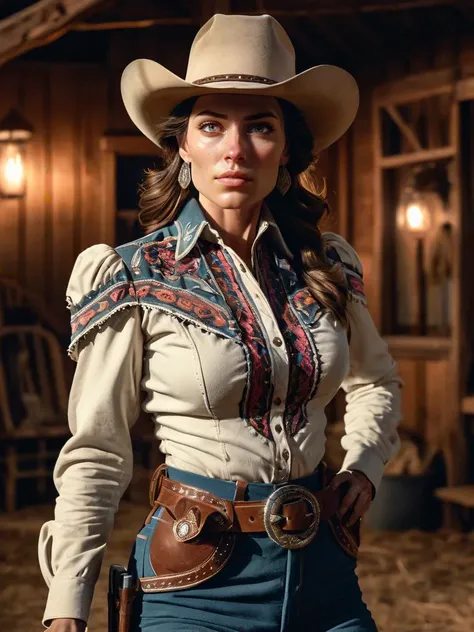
[150,468,340,549]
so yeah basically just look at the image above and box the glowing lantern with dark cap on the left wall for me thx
[0,109,33,198]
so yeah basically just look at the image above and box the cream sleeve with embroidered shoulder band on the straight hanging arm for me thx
[39,245,143,625]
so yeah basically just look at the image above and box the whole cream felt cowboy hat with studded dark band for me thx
[121,14,359,151]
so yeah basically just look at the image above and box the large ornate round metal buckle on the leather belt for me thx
[263,485,321,549]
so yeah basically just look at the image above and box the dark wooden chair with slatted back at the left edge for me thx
[0,325,69,512]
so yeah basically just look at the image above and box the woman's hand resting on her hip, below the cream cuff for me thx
[330,470,375,527]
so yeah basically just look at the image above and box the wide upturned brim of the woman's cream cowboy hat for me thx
[121,59,359,152]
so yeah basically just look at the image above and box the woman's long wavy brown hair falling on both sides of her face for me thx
[139,98,348,328]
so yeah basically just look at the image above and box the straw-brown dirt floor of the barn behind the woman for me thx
[0,501,474,632]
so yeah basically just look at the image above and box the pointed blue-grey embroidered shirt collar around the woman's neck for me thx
[174,198,293,261]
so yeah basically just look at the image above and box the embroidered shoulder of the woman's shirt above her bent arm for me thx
[322,233,367,306]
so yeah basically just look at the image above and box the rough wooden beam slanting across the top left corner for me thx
[0,0,110,66]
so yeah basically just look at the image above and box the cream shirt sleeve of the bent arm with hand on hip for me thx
[323,233,403,489]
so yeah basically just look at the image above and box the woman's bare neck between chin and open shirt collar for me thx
[199,195,262,266]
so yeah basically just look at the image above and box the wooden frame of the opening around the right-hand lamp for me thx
[372,68,474,484]
